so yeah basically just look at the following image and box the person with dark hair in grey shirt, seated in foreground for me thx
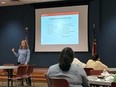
[47,47,89,87]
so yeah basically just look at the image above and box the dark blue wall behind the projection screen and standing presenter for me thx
[0,0,100,67]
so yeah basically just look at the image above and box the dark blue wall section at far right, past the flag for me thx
[98,0,116,67]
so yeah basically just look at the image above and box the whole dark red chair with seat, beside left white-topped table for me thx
[9,65,27,87]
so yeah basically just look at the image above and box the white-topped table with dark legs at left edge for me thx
[0,66,18,87]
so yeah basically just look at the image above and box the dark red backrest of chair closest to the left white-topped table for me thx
[16,65,27,77]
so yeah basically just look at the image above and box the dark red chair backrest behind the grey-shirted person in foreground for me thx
[51,78,69,87]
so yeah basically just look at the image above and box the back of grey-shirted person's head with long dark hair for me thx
[59,47,74,71]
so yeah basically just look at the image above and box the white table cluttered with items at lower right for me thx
[87,76,113,86]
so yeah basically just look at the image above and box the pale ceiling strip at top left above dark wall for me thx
[0,0,62,7]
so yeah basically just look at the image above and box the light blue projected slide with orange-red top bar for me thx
[41,12,79,45]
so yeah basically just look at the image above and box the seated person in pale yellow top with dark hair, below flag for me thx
[86,54,109,70]
